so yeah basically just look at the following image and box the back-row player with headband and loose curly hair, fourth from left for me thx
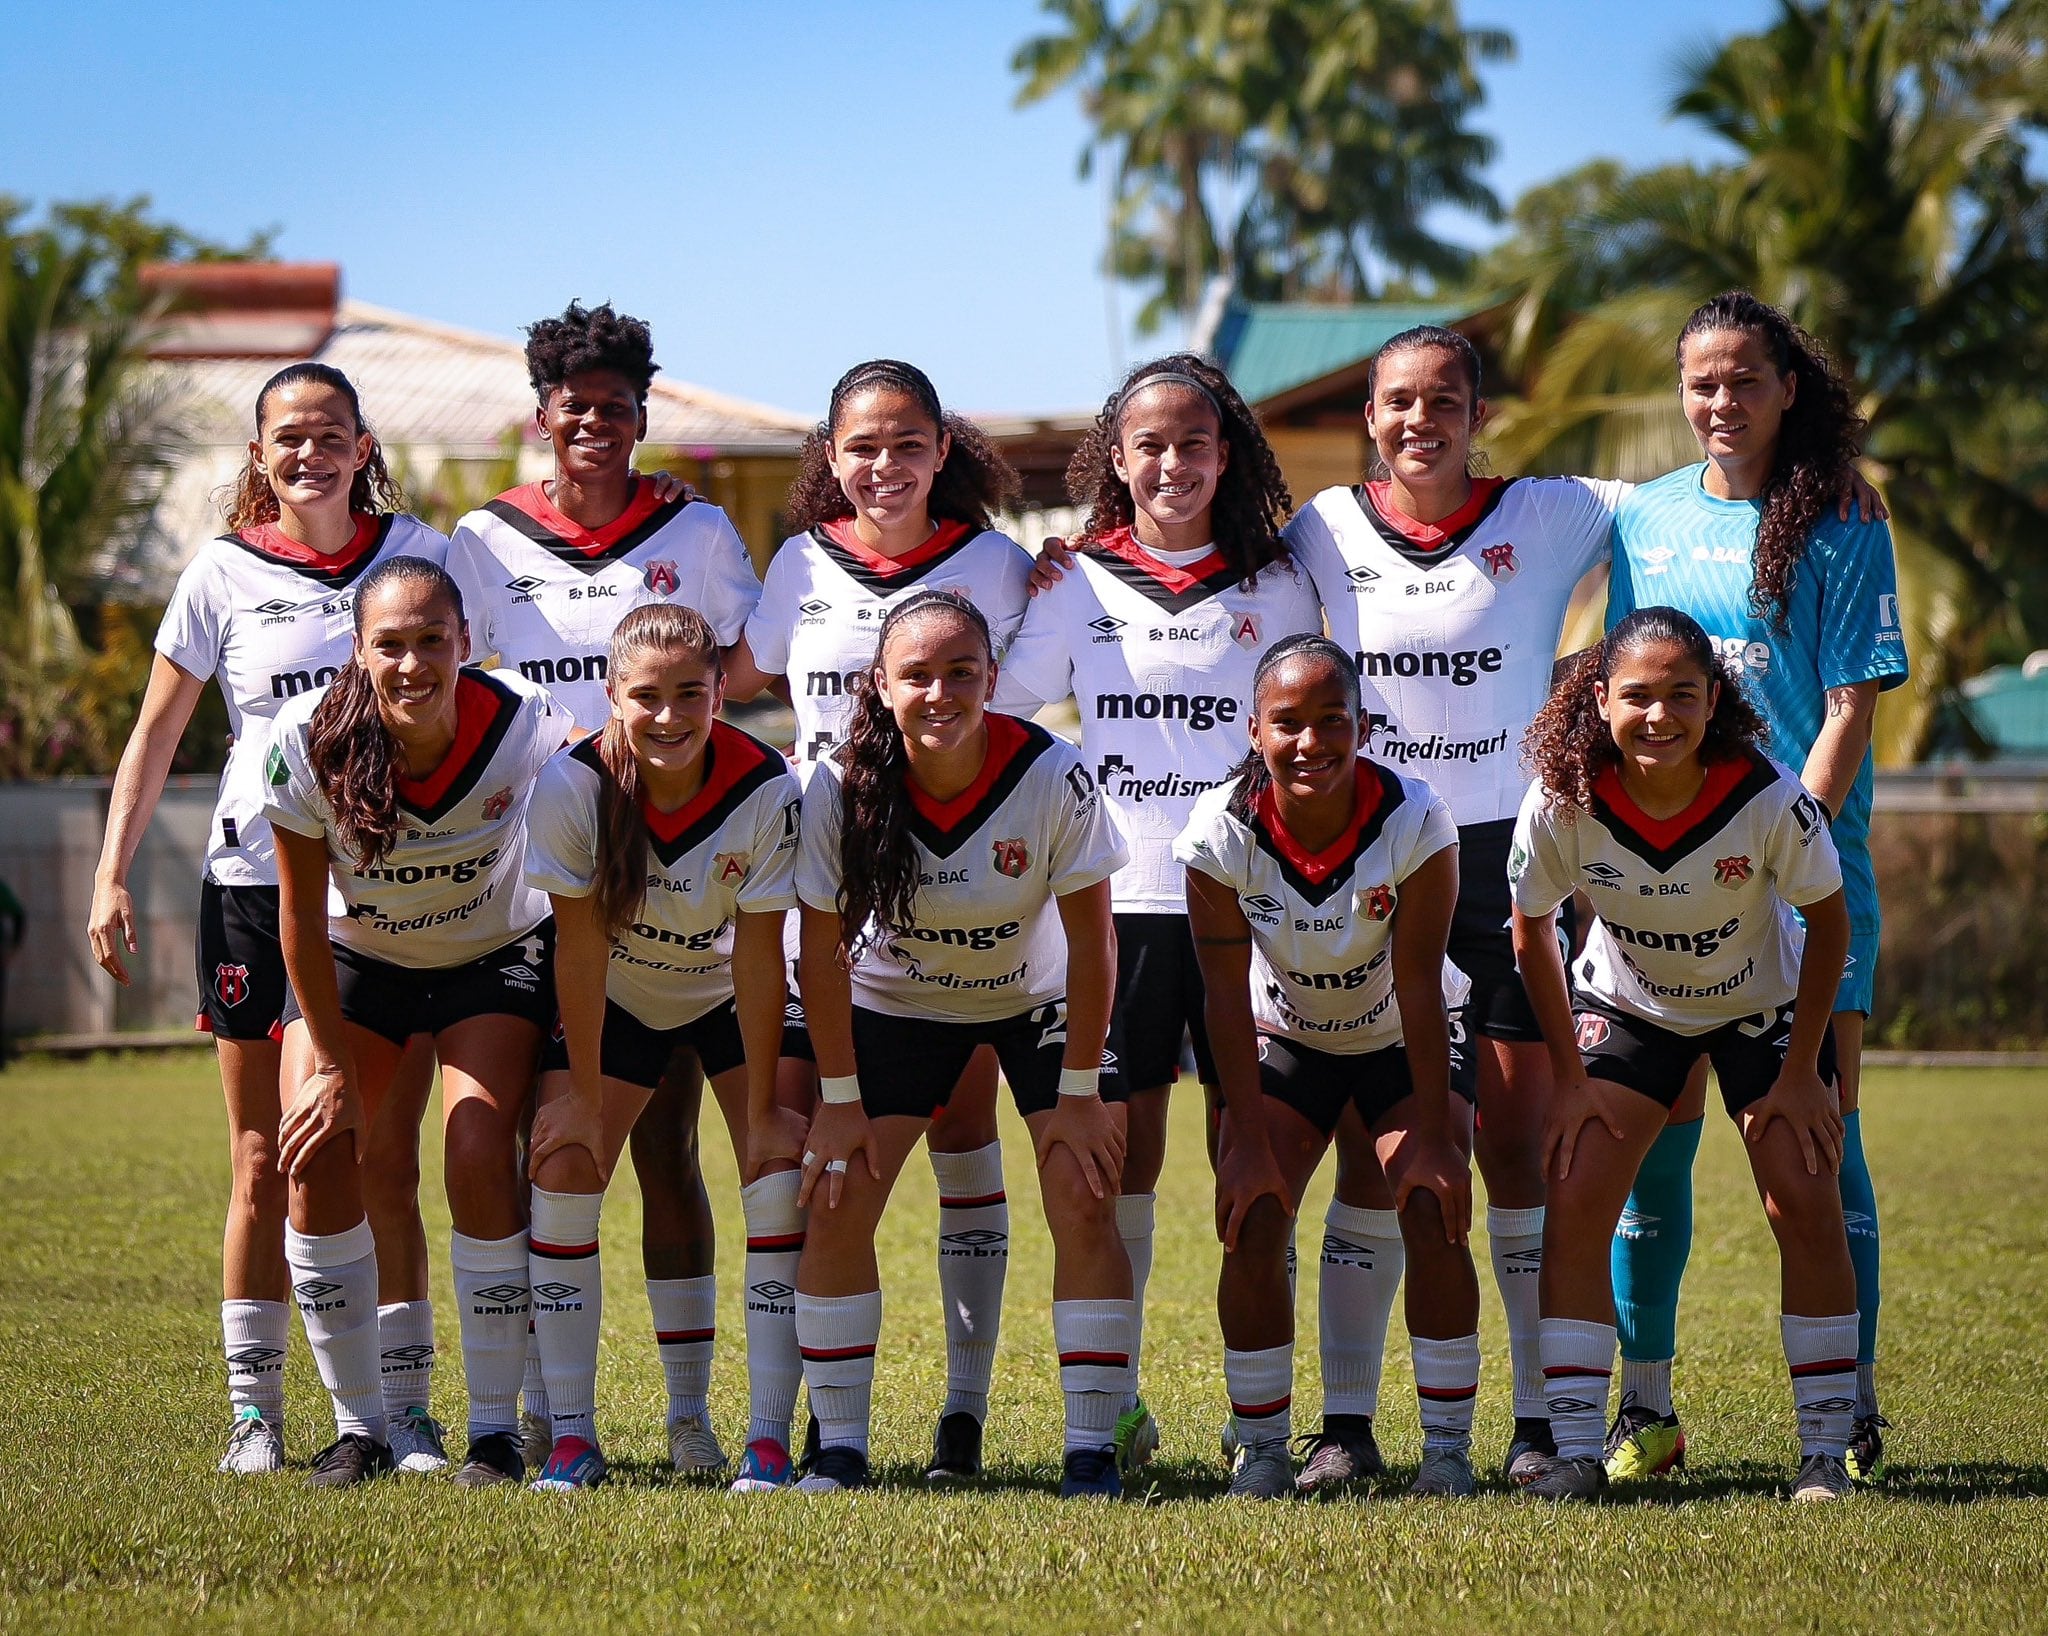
[997,352,1323,1472]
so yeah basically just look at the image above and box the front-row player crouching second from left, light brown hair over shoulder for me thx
[526,602,803,1491]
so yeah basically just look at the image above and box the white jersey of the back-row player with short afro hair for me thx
[449,477,762,733]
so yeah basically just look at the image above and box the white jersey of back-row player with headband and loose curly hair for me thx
[995,530,1323,915]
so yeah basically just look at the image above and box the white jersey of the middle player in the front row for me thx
[797,711,1124,1022]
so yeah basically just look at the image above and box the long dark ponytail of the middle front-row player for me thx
[838,592,995,962]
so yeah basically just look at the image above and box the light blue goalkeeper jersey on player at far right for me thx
[1608,463,1907,844]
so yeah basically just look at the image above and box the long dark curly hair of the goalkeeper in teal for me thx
[1677,291,1868,633]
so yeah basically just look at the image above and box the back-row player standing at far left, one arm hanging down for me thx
[88,362,449,1474]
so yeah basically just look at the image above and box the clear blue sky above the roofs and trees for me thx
[0,0,1776,414]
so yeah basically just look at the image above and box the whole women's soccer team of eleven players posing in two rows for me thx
[90,293,1907,1499]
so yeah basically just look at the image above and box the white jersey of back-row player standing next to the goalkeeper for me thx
[1286,477,1628,825]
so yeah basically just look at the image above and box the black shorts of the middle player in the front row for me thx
[854,999,1128,1120]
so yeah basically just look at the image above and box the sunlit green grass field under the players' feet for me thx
[0,1054,2048,1636]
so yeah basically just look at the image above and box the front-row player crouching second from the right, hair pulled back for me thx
[1174,637,1479,1499]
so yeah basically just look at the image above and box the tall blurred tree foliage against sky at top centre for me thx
[1012,0,1513,330]
